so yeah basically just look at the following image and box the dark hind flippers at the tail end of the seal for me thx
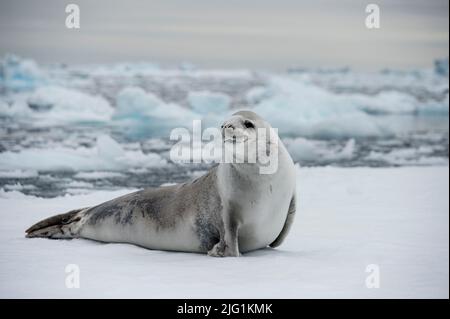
[25,208,86,239]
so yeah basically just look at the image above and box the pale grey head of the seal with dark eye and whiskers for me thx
[221,111,278,174]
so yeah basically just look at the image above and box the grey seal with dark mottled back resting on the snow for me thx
[26,111,296,257]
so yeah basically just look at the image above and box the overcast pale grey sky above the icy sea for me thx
[0,0,449,70]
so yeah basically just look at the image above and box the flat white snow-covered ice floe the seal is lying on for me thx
[0,166,449,298]
